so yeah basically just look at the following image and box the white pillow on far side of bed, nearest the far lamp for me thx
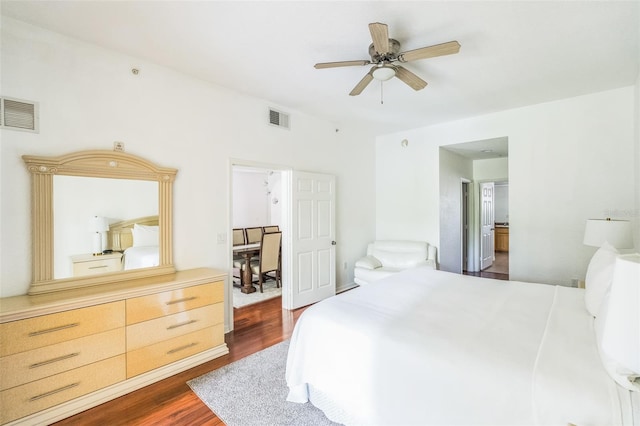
[584,242,618,317]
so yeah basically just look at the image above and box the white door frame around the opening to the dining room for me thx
[224,158,293,333]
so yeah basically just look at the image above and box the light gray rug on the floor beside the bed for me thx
[187,340,336,426]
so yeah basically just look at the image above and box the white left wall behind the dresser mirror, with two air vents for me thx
[0,17,375,296]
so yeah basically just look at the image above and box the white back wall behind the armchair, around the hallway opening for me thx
[376,87,638,285]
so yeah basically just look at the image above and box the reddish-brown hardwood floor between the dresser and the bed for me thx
[55,297,305,426]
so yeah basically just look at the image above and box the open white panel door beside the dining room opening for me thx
[287,172,336,309]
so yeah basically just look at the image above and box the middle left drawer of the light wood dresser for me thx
[0,327,126,390]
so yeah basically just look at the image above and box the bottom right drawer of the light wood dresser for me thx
[127,324,224,378]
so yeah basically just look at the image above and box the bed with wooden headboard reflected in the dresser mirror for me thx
[108,216,160,270]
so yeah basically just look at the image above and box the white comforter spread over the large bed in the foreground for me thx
[286,268,622,425]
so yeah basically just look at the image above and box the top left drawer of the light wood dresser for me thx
[0,301,125,356]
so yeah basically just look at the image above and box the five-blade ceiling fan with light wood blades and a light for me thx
[314,22,460,96]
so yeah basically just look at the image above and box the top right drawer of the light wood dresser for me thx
[127,281,224,324]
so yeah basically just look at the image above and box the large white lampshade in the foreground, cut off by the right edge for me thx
[602,253,640,374]
